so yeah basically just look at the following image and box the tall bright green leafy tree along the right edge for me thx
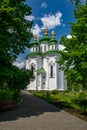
[58,0,87,88]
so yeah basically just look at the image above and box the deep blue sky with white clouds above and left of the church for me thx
[15,0,75,68]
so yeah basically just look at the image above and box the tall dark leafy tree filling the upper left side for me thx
[0,0,32,86]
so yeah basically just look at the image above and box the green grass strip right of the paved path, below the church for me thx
[32,90,87,121]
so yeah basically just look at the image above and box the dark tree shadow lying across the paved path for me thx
[0,91,60,122]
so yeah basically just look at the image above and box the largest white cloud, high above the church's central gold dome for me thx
[41,12,62,29]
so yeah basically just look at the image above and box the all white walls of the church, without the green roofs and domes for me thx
[26,43,67,90]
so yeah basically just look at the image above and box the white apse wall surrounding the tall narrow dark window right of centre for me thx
[43,55,58,90]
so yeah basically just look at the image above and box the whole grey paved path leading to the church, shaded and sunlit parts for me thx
[0,92,87,130]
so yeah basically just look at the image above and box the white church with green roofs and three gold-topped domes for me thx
[26,28,67,91]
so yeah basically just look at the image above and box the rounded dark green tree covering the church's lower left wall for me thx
[7,66,33,98]
